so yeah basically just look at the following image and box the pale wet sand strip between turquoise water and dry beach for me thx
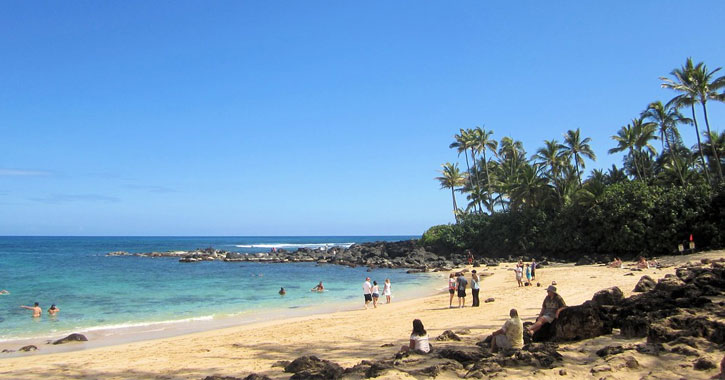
[0,272,443,361]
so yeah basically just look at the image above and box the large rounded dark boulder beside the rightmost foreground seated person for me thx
[554,302,612,341]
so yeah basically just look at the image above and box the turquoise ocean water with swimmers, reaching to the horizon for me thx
[0,236,431,341]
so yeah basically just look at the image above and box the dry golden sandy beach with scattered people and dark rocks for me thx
[0,251,725,379]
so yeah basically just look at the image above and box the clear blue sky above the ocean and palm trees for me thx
[0,1,725,235]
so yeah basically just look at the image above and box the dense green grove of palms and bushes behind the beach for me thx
[430,58,725,258]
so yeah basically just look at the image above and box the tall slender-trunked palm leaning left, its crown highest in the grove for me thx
[660,58,710,183]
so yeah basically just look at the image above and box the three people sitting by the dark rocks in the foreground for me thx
[401,285,566,354]
